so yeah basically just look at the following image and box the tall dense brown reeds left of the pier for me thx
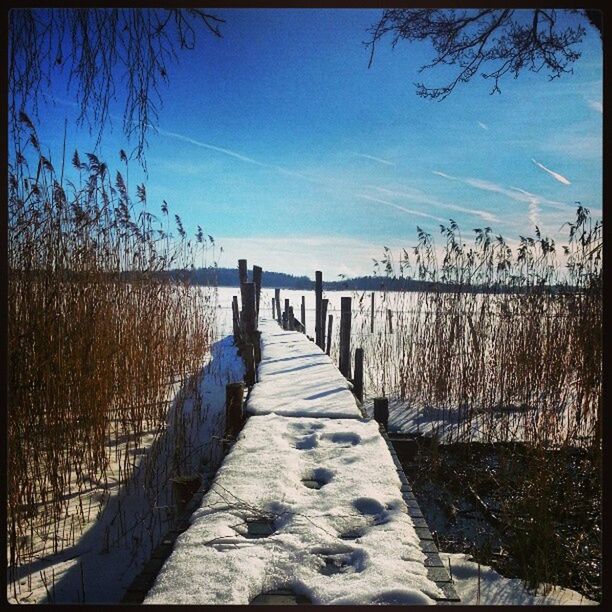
[7,114,215,580]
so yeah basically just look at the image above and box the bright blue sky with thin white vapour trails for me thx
[25,9,603,279]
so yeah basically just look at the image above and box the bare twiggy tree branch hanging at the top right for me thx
[365,9,601,100]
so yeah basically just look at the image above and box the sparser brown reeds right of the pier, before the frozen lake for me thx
[340,207,603,446]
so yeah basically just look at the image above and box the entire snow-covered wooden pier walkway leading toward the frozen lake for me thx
[144,320,457,604]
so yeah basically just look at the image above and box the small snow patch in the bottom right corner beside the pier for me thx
[440,552,598,606]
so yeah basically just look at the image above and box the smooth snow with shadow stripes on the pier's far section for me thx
[247,320,361,418]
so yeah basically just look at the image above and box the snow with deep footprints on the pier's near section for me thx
[145,414,441,604]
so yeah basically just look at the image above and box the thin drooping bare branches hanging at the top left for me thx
[9,8,223,168]
